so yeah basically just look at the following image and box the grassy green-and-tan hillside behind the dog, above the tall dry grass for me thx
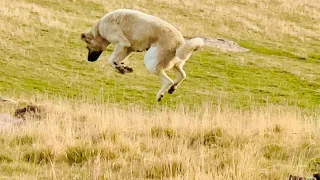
[0,0,320,108]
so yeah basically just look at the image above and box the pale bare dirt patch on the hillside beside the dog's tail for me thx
[184,36,249,52]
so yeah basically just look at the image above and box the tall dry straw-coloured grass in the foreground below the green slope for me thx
[0,97,320,180]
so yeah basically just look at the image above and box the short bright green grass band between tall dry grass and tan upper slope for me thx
[1,34,320,108]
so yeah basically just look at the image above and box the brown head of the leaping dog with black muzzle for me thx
[81,33,110,62]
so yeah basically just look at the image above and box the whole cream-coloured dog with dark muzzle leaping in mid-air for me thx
[81,9,204,101]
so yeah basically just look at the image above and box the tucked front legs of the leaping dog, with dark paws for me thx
[109,44,133,74]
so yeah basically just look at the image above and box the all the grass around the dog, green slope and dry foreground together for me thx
[0,0,320,180]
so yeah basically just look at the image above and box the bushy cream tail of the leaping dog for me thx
[176,38,204,61]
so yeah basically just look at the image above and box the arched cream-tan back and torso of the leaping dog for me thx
[100,9,184,51]
